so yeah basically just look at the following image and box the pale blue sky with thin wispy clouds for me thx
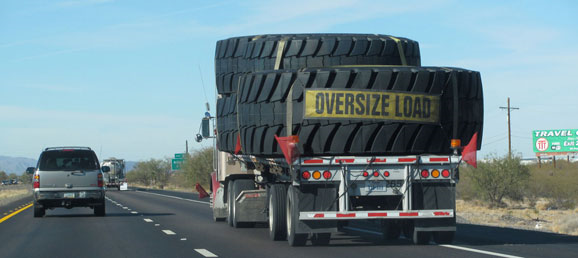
[0,0,578,161]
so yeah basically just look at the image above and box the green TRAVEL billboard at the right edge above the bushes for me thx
[532,129,578,155]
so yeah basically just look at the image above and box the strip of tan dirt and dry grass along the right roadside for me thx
[456,200,578,236]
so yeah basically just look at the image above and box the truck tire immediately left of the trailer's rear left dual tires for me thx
[269,184,287,241]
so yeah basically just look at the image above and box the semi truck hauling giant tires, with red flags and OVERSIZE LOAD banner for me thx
[197,34,483,246]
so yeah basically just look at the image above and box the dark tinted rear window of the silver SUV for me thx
[38,150,100,171]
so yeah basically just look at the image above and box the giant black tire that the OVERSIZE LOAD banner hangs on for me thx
[235,66,483,157]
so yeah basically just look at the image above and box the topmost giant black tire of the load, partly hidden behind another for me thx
[215,34,421,94]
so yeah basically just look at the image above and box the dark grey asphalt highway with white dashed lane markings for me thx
[0,189,578,258]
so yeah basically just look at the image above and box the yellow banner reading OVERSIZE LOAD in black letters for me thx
[305,89,440,123]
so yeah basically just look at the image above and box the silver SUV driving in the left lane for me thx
[26,147,110,217]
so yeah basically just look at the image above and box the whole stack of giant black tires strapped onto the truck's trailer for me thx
[215,34,483,157]
